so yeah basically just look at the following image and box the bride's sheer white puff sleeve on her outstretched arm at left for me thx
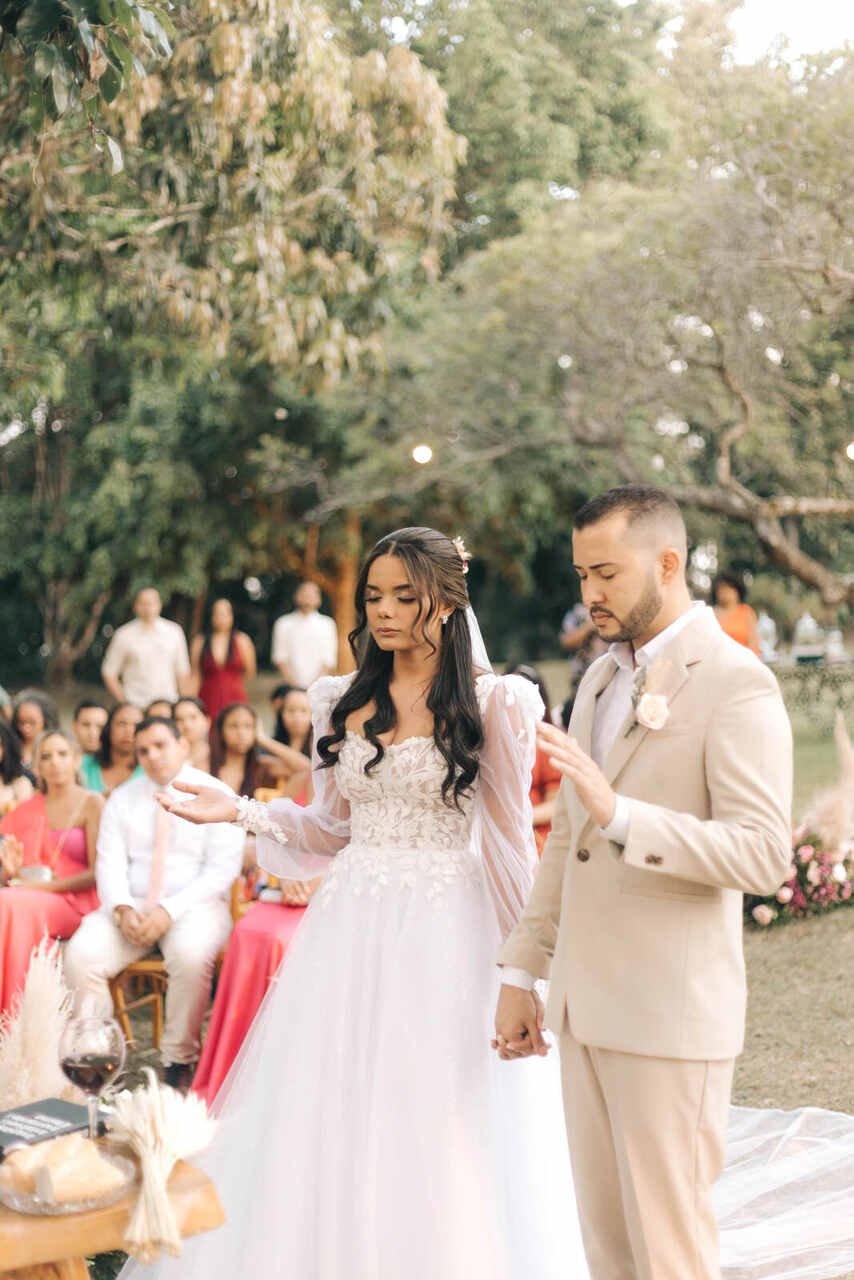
[237,676,352,879]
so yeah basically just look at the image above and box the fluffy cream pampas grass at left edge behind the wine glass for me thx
[0,937,85,1111]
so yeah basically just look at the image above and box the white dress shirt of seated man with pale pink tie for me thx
[95,764,246,920]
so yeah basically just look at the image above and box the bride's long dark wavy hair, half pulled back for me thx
[318,529,483,808]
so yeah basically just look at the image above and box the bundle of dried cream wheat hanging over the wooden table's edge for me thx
[108,1066,216,1262]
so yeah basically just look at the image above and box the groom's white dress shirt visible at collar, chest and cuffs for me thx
[501,600,705,991]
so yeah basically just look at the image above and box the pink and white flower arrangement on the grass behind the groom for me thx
[744,828,854,928]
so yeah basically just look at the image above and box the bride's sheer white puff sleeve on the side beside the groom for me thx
[472,675,543,937]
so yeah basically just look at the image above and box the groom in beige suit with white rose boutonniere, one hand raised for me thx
[493,485,791,1280]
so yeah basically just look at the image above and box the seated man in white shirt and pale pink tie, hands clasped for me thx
[65,718,243,1088]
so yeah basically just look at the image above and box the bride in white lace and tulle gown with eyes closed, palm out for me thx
[123,529,588,1280]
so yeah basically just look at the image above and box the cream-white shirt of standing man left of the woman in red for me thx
[101,618,189,708]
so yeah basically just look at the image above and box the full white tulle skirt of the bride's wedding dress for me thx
[123,854,588,1280]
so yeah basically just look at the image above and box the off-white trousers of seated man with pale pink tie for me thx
[64,900,232,1062]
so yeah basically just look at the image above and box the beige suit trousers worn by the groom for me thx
[560,1023,734,1280]
